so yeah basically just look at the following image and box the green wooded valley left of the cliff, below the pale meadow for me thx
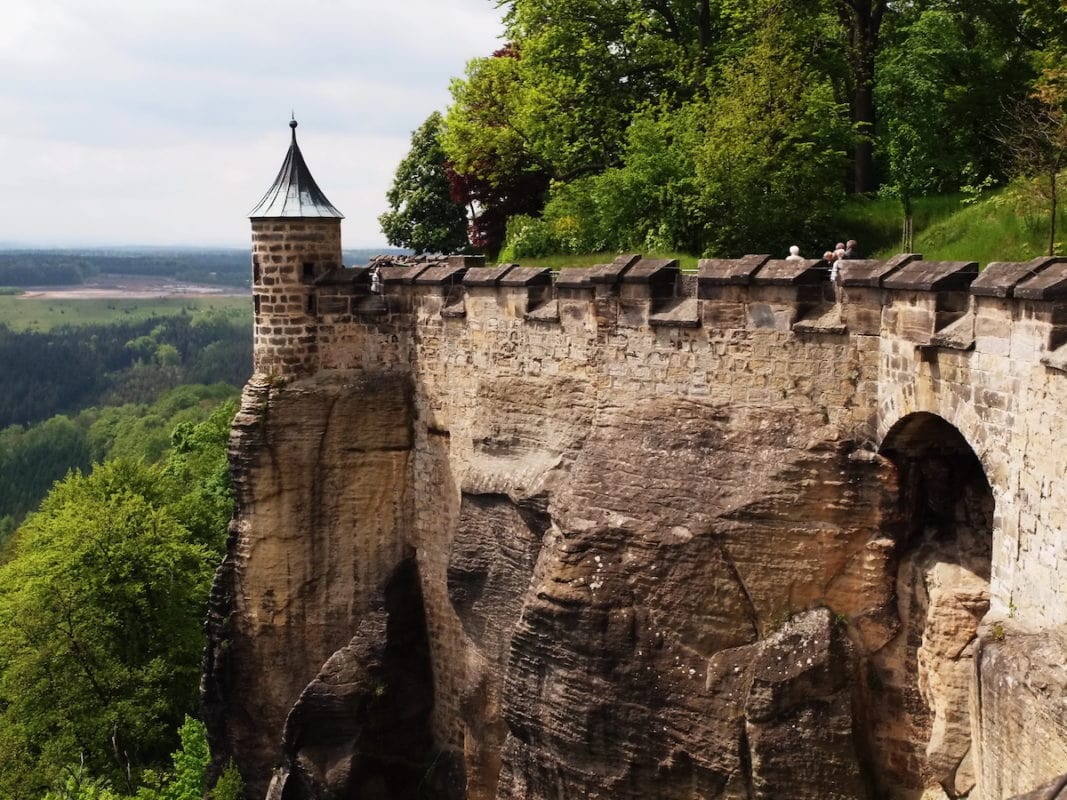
[0,296,252,800]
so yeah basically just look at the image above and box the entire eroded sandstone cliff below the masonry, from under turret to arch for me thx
[206,375,1007,800]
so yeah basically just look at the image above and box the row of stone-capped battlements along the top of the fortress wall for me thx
[256,254,1067,378]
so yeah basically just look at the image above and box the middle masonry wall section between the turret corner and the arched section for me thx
[375,273,878,747]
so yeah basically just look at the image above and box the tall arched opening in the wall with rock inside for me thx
[866,413,993,800]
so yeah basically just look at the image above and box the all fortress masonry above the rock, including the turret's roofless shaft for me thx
[237,166,1067,797]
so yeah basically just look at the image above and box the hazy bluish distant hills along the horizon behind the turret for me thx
[0,246,408,286]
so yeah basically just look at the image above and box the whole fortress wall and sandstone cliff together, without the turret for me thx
[204,253,1067,800]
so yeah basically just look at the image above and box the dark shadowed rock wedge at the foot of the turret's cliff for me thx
[268,560,464,800]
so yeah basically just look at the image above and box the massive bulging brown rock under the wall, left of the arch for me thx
[488,400,889,800]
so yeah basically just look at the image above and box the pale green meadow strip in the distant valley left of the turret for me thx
[0,294,252,331]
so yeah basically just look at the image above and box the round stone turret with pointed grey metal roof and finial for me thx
[249,119,344,378]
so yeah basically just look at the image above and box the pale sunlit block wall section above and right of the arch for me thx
[878,292,1067,628]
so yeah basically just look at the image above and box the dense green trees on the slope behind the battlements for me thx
[380,0,1067,260]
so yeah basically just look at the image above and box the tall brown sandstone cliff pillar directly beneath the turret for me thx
[204,374,411,796]
